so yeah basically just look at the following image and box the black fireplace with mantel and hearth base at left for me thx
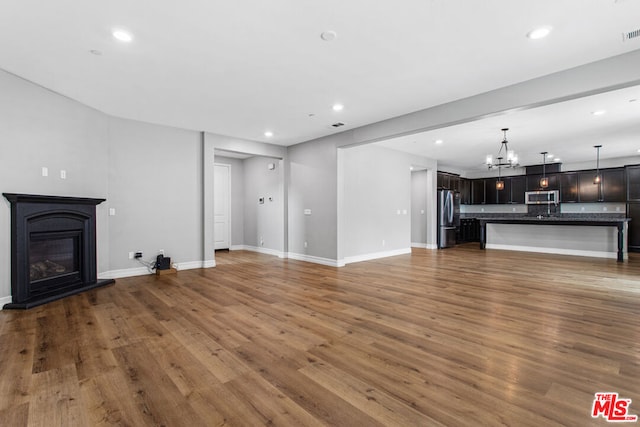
[3,193,114,309]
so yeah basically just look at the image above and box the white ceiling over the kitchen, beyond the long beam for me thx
[377,86,640,172]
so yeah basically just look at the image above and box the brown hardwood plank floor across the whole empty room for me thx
[0,244,640,427]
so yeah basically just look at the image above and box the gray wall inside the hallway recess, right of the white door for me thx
[244,157,285,254]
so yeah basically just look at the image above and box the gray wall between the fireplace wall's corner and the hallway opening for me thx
[109,118,204,270]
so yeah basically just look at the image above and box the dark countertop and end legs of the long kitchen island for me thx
[476,215,631,262]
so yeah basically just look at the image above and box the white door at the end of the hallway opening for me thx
[213,164,231,249]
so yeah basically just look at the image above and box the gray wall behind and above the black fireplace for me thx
[0,71,109,302]
